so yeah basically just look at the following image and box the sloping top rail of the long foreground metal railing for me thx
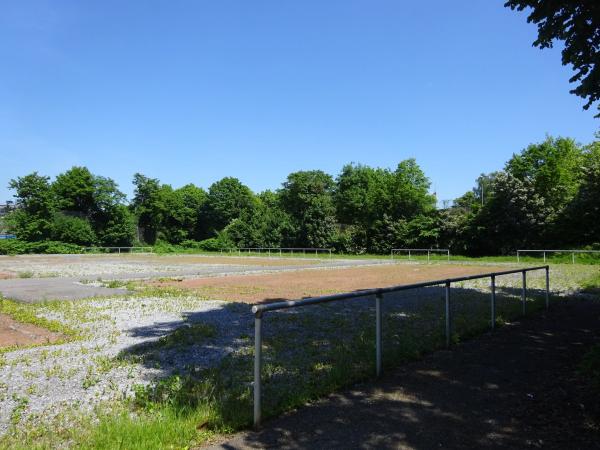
[252,265,550,315]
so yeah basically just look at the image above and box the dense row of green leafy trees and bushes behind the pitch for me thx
[4,137,600,256]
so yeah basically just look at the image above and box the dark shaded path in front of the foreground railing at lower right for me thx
[213,301,600,449]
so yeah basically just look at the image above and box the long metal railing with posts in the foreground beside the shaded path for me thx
[252,266,550,427]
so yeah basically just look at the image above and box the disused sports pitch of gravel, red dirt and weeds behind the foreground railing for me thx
[0,255,598,448]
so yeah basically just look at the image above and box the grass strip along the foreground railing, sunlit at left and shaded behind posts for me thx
[76,284,543,448]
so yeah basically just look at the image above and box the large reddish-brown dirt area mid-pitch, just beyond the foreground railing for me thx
[150,264,507,303]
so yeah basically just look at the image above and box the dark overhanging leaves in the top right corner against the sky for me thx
[504,0,600,118]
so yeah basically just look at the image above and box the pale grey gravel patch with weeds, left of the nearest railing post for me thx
[0,298,250,434]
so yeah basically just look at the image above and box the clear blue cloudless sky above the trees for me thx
[0,0,600,202]
